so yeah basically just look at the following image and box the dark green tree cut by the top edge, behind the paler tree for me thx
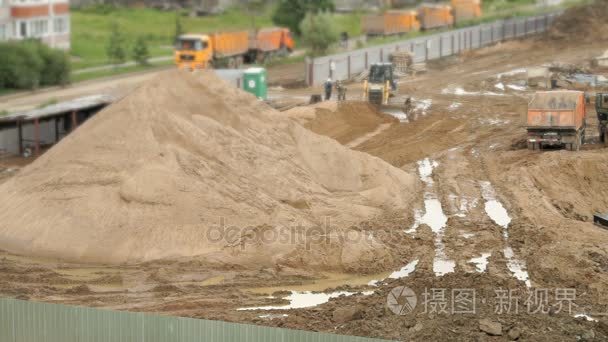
[272,0,334,35]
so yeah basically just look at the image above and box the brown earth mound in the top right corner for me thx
[548,0,608,42]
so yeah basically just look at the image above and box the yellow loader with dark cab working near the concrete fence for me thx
[363,63,397,105]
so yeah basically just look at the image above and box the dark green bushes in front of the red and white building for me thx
[0,40,70,89]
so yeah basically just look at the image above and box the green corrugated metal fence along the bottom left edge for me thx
[0,298,394,342]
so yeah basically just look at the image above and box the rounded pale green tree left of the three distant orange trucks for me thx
[300,12,340,55]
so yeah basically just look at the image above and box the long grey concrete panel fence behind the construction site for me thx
[306,14,557,85]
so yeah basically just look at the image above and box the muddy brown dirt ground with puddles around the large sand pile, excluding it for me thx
[0,4,608,341]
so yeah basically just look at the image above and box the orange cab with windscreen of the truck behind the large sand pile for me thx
[175,34,213,70]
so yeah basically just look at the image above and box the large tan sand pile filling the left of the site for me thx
[0,71,415,269]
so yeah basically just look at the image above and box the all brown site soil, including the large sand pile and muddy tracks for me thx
[0,6,608,341]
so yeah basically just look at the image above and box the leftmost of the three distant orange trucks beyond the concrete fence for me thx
[361,10,420,36]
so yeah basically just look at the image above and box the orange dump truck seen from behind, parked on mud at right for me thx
[526,90,587,151]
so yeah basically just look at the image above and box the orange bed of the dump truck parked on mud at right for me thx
[526,90,586,130]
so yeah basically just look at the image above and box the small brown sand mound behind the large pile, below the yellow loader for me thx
[286,101,397,144]
